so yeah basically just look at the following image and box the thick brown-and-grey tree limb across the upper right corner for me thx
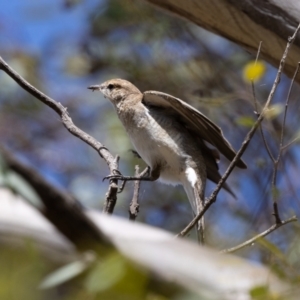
[147,0,300,82]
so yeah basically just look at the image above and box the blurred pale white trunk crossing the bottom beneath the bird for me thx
[0,189,297,299]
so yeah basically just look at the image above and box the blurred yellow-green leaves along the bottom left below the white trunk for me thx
[0,239,193,300]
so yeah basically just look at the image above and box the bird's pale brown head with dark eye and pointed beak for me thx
[88,79,141,105]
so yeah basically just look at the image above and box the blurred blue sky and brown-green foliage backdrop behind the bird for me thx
[0,0,300,299]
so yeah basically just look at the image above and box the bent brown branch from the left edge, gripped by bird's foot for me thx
[0,57,118,213]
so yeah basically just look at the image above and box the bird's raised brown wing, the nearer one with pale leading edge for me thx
[143,91,247,169]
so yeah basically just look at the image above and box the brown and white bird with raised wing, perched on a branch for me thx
[88,78,247,243]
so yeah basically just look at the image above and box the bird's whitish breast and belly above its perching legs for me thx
[126,108,187,183]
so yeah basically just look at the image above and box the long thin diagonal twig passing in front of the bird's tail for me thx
[177,24,300,237]
